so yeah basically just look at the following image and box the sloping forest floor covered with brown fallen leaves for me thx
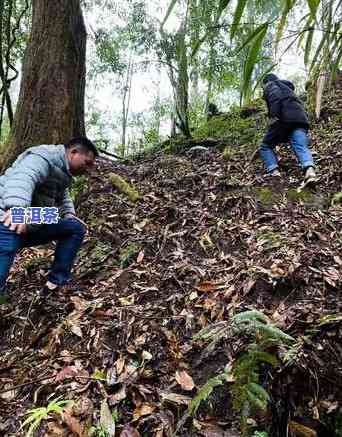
[0,76,342,437]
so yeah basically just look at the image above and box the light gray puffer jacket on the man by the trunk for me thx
[0,144,75,231]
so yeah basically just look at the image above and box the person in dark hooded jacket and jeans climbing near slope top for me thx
[260,74,317,184]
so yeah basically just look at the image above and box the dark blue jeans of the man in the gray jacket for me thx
[0,218,86,290]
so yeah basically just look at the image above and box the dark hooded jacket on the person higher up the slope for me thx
[264,79,309,127]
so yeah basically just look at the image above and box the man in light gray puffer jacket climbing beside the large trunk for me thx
[0,137,98,302]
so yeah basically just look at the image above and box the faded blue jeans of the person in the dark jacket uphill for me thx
[260,128,314,172]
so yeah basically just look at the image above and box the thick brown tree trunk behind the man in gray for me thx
[0,0,87,169]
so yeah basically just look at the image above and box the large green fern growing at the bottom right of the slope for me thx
[190,310,295,436]
